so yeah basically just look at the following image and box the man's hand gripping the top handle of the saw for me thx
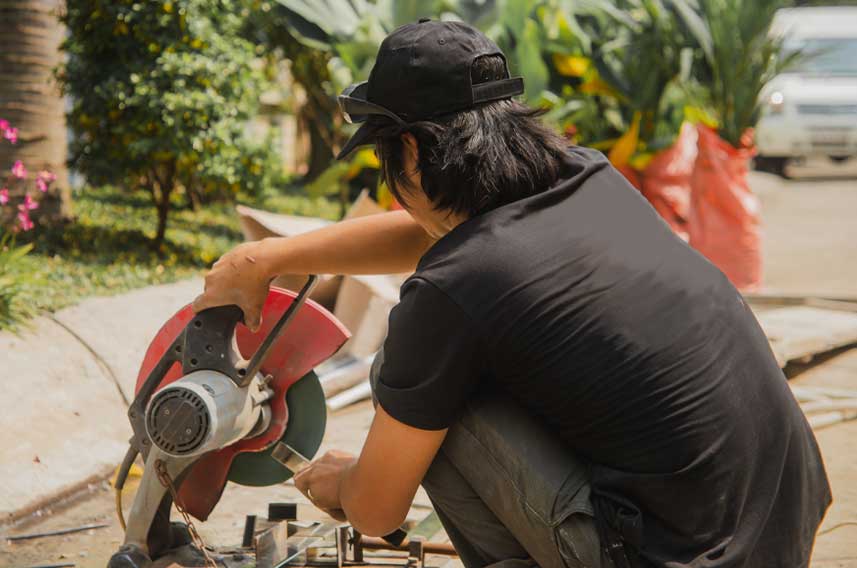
[193,241,273,331]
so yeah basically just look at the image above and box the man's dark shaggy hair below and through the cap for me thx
[375,55,568,217]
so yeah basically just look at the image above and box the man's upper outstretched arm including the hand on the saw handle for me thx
[193,211,433,330]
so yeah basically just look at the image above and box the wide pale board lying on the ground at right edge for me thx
[756,306,857,367]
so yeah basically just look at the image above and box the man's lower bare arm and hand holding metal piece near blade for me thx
[295,405,446,536]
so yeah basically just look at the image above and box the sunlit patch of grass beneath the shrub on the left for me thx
[10,187,339,320]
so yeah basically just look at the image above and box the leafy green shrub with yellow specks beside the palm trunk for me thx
[60,0,279,242]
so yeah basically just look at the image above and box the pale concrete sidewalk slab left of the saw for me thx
[0,279,202,524]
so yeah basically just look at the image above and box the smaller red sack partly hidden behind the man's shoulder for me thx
[637,123,697,241]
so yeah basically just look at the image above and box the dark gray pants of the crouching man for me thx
[372,353,613,568]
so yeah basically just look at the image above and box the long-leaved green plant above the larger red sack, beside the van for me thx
[697,0,801,147]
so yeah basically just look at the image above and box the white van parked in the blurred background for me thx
[756,7,857,176]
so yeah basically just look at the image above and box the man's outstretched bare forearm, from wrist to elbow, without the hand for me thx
[252,211,432,277]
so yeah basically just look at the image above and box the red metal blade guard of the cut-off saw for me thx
[135,287,350,521]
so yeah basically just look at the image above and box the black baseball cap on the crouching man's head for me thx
[336,18,524,159]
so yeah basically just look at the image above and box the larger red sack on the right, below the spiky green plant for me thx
[689,125,762,291]
